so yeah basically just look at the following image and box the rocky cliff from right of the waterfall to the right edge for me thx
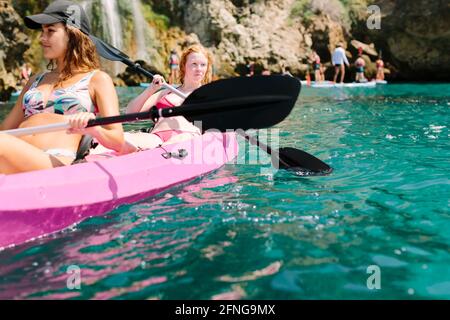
[146,0,450,81]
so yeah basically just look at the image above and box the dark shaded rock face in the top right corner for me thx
[370,0,450,81]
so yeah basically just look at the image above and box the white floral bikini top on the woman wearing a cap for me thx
[22,71,98,118]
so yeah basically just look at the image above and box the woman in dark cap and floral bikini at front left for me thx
[0,1,124,174]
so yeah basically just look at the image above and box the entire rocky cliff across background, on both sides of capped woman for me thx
[0,0,450,101]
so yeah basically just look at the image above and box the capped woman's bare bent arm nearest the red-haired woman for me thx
[85,71,124,151]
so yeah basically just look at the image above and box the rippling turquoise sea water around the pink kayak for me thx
[0,84,450,299]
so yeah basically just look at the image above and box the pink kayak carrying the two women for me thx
[0,133,238,249]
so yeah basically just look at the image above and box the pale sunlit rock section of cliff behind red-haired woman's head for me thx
[183,0,343,75]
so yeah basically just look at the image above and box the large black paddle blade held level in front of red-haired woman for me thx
[178,76,301,131]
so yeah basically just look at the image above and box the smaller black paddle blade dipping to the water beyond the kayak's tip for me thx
[272,147,333,176]
